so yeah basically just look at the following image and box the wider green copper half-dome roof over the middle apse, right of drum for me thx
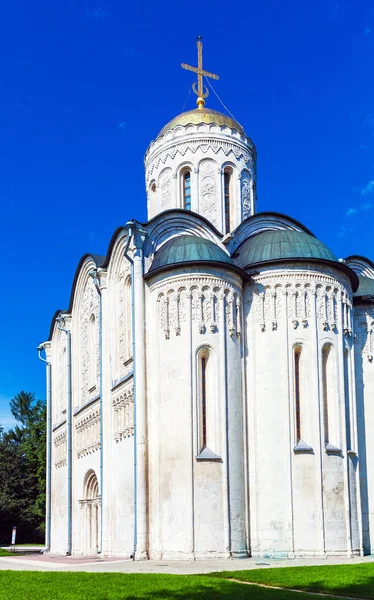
[236,229,338,268]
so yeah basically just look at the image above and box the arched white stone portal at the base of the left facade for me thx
[79,470,100,555]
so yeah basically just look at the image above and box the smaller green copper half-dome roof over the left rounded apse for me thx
[150,235,233,272]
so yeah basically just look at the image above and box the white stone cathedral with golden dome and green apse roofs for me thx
[39,43,374,560]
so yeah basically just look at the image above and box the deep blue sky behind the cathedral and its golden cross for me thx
[0,0,374,426]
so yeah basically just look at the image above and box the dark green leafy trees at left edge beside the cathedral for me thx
[0,391,46,543]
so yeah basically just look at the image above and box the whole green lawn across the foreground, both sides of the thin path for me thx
[0,563,374,600]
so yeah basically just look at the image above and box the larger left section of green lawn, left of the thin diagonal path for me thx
[0,571,316,600]
